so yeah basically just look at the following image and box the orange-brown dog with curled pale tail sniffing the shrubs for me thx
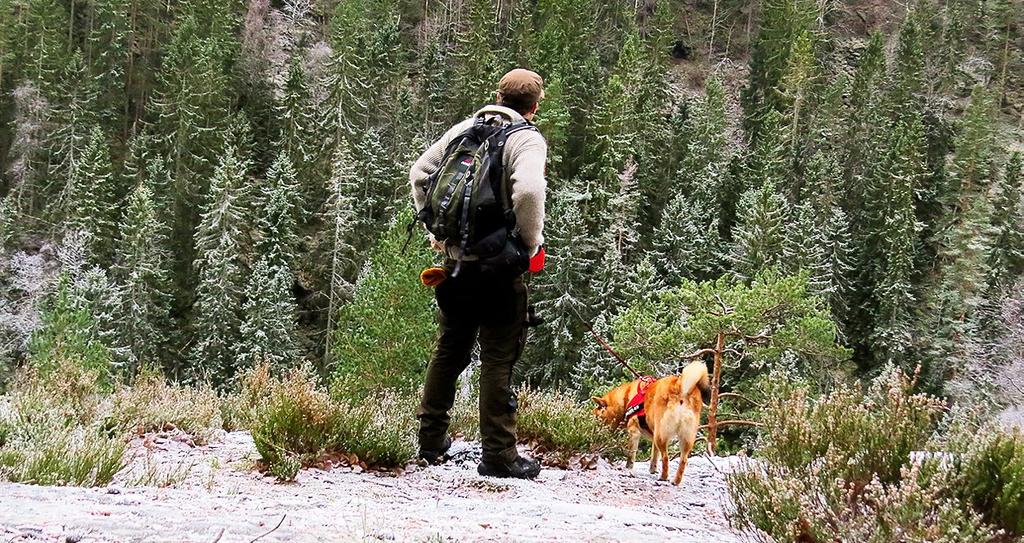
[593,361,711,485]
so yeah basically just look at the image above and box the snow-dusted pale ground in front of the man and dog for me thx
[0,432,741,543]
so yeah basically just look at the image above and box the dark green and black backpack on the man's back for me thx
[410,117,537,276]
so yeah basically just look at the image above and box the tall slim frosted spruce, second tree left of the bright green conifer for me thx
[191,143,249,382]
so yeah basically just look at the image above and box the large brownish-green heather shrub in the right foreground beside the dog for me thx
[728,371,997,543]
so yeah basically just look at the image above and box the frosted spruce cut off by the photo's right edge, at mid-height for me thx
[988,153,1024,289]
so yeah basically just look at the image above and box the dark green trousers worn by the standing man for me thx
[418,262,527,462]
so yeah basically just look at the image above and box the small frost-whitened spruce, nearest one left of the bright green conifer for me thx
[237,257,297,370]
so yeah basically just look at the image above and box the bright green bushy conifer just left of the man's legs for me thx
[332,212,436,391]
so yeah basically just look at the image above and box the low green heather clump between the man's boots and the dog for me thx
[516,387,626,465]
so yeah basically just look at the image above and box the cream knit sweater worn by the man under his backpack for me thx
[409,106,548,258]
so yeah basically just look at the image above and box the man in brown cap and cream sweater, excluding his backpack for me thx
[410,69,548,478]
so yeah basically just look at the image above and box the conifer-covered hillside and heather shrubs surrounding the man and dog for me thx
[0,0,1024,542]
